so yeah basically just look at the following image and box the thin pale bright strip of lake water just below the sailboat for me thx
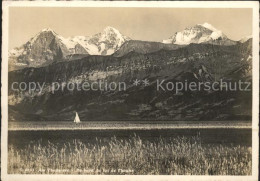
[8,121,252,131]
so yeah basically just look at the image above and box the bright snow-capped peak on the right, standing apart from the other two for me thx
[163,23,227,45]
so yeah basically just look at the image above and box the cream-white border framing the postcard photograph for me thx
[1,1,259,181]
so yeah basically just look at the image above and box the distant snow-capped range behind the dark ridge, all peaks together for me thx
[9,23,248,71]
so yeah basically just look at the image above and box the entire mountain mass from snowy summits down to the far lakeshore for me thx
[8,24,252,121]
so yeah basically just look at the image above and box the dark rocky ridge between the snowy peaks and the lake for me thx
[8,39,252,121]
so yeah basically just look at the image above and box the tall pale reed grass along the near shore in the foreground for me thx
[8,135,252,175]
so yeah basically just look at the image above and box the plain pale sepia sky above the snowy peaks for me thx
[9,7,252,49]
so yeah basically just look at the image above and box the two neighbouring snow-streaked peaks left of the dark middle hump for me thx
[9,27,130,70]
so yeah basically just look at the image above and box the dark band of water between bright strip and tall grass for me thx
[8,128,252,149]
